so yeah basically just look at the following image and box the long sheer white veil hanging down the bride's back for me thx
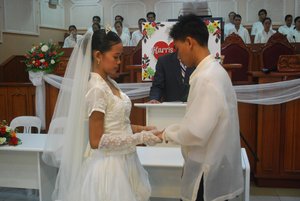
[42,32,92,201]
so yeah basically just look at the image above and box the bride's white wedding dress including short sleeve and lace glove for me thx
[80,73,157,201]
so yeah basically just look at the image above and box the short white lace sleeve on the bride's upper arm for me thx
[85,87,108,116]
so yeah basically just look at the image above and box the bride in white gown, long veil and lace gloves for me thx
[43,30,161,201]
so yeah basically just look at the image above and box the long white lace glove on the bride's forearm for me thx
[98,131,161,150]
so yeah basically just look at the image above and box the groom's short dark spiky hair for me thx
[170,14,208,47]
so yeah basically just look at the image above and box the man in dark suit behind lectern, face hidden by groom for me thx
[149,52,195,103]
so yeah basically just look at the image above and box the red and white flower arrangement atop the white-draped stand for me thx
[23,43,64,73]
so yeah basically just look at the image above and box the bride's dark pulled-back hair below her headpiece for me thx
[92,29,122,53]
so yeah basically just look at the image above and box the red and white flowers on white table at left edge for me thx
[0,120,22,146]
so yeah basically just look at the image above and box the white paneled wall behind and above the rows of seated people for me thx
[0,0,300,35]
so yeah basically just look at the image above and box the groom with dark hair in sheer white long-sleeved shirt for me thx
[158,15,243,201]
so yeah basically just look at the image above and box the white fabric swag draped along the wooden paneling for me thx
[30,74,300,129]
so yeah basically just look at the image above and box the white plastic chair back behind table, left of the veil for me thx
[10,116,42,134]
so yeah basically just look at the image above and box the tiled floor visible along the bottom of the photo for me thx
[0,185,300,201]
